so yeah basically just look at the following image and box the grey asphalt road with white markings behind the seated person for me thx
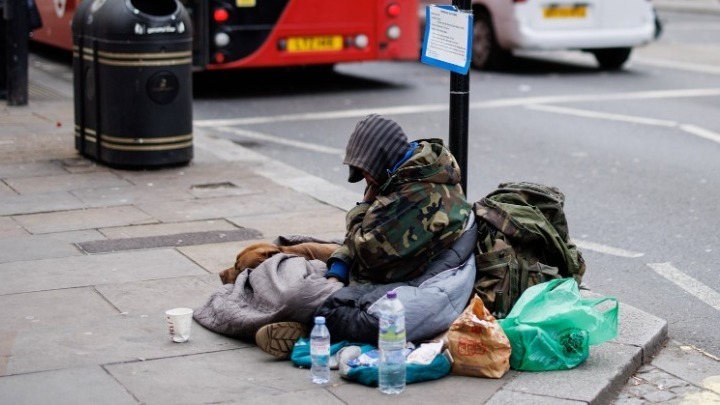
[194,8,720,355]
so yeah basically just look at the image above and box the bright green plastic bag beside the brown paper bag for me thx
[498,278,619,371]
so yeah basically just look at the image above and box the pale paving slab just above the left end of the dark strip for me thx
[13,205,158,234]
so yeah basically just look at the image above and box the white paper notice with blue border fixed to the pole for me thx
[420,5,473,74]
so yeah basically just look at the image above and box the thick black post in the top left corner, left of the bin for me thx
[5,0,30,106]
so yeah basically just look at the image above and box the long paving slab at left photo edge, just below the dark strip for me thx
[0,249,207,295]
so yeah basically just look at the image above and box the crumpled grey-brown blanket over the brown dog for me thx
[193,253,342,341]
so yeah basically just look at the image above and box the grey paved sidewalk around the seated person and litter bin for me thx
[0,63,667,404]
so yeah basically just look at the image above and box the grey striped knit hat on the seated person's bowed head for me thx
[343,114,410,184]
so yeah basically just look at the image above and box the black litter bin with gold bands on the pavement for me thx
[72,0,193,168]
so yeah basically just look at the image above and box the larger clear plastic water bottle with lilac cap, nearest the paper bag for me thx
[378,291,406,394]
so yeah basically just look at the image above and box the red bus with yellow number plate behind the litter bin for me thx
[33,0,419,70]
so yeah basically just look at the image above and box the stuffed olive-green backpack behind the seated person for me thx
[473,182,585,319]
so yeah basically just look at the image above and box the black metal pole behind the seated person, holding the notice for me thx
[450,0,472,194]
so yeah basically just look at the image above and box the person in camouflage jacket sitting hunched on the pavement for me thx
[196,114,477,358]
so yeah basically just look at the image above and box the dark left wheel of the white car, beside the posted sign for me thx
[471,12,510,70]
